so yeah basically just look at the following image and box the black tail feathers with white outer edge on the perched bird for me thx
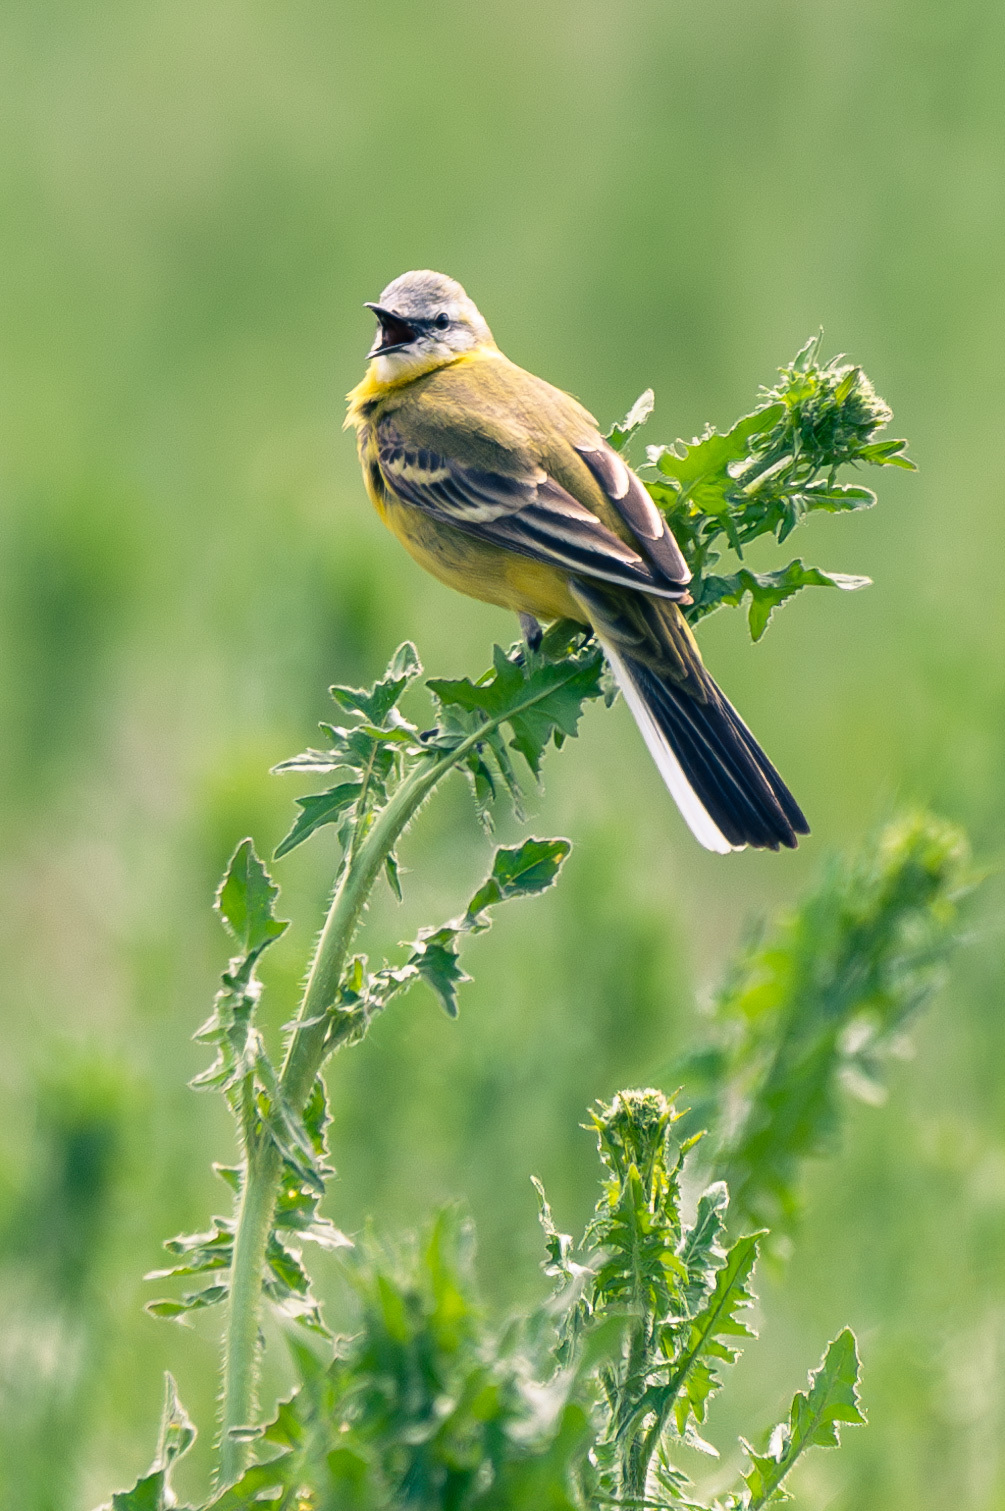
[601,636,809,854]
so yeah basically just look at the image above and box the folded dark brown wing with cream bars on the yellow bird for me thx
[378,423,689,600]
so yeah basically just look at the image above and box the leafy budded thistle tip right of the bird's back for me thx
[628,335,914,641]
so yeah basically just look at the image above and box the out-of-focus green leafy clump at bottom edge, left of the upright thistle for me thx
[147,1209,592,1511]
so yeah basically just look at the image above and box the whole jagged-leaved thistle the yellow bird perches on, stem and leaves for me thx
[98,343,911,1506]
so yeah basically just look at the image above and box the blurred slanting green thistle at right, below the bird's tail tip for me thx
[674,813,973,1227]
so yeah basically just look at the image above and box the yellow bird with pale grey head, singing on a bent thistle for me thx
[345,269,809,854]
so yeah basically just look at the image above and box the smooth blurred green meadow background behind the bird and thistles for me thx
[0,0,1005,1511]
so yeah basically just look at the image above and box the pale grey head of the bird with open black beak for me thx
[367,270,496,382]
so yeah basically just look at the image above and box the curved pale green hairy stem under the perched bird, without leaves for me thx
[219,668,589,1485]
